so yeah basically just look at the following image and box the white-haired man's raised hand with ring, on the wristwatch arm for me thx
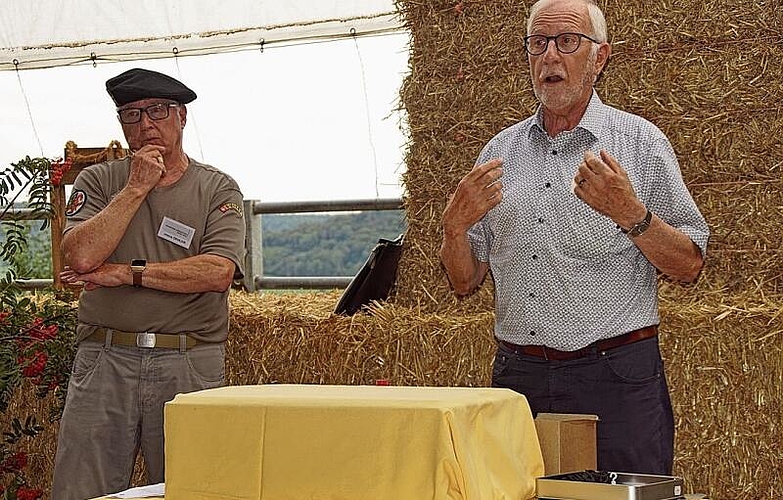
[574,150,647,229]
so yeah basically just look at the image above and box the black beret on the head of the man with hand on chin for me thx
[106,68,196,106]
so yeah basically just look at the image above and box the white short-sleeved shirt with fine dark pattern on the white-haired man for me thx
[468,92,709,351]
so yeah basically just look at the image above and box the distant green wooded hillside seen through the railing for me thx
[0,210,406,279]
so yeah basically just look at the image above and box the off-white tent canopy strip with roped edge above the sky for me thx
[0,0,401,70]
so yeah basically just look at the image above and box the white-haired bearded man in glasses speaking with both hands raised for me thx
[441,0,709,474]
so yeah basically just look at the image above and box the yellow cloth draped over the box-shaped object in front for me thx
[165,385,544,500]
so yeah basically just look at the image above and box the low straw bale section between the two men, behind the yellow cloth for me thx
[227,293,493,387]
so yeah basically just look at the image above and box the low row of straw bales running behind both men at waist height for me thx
[0,288,783,500]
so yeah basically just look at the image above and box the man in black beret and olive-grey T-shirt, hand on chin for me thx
[52,69,245,500]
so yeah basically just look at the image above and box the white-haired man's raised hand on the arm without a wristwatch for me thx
[442,158,503,234]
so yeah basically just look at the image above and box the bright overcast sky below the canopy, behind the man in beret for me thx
[0,33,408,201]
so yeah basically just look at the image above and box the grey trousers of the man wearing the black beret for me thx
[51,341,225,500]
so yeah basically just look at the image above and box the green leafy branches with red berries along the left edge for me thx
[0,156,77,500]
